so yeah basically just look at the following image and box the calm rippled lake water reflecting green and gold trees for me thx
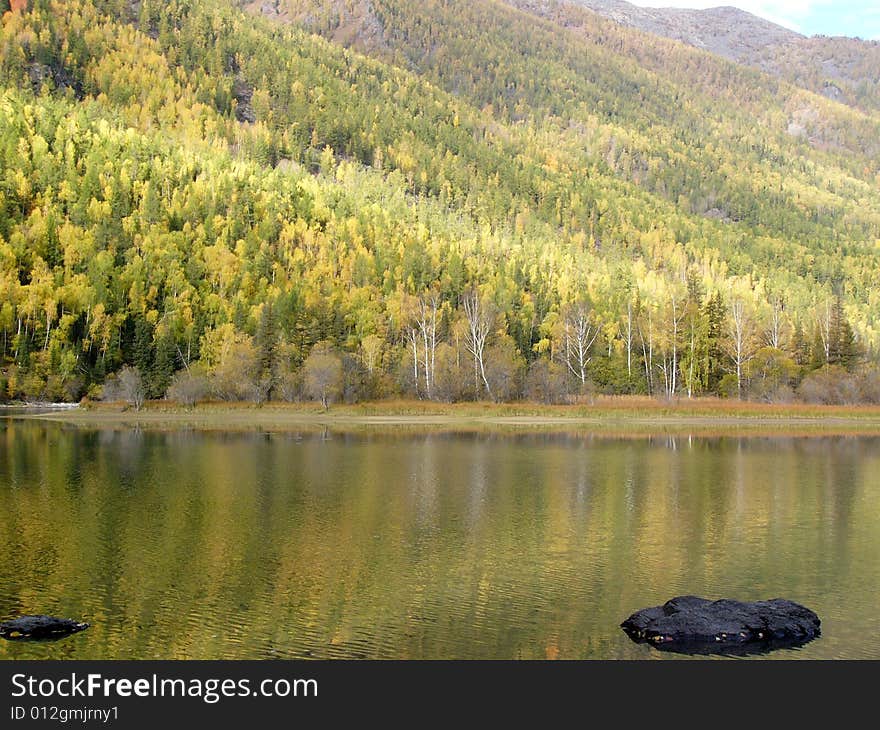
[0,419,880,659]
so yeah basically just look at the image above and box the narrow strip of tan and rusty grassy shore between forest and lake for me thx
[8,397,880,435]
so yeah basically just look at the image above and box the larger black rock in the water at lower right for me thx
[620,596,820,654]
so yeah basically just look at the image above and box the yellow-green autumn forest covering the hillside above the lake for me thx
[0,0,880,406]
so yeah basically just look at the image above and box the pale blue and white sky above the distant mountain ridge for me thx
[629,0,880,40]
